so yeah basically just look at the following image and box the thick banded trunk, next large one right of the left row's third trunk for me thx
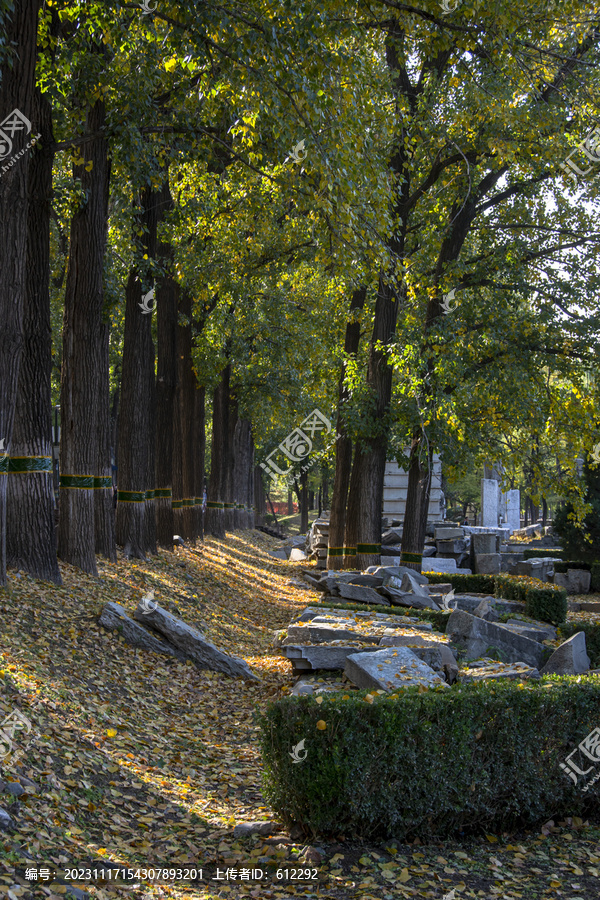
[117,188,158,559]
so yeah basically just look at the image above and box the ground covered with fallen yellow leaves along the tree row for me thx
[0,532,600,900]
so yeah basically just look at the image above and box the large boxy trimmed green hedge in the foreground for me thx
[258,676,600,841]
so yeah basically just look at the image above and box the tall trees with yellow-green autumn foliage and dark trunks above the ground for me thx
[0,0,600,582]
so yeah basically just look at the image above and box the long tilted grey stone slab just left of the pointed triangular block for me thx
[446,610,544,668]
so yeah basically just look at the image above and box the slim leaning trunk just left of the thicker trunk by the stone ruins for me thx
[327,287,367,569]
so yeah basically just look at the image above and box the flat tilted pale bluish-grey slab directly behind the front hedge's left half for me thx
[344,647,447,691]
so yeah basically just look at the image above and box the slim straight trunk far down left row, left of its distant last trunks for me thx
[206,364,231,538]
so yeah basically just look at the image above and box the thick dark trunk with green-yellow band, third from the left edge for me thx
[58,100,110,575]
